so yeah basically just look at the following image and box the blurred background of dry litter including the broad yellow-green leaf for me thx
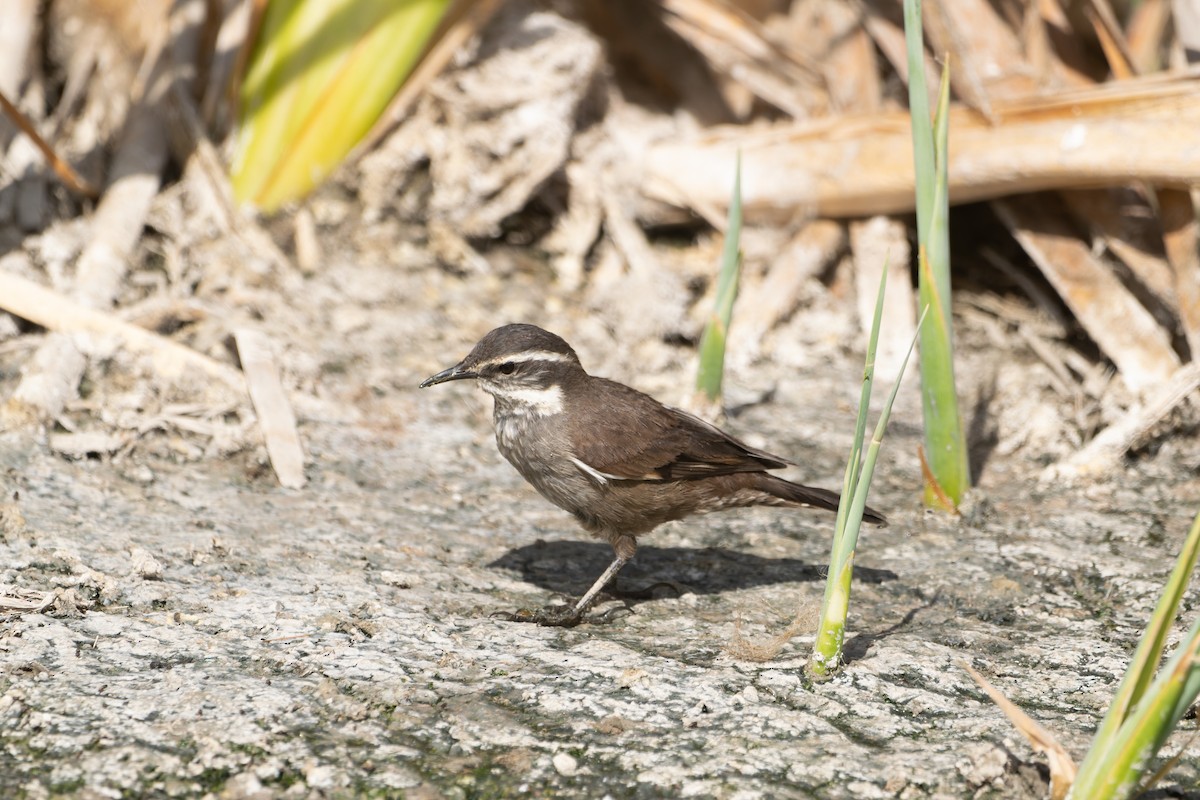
[0,0,1200,482]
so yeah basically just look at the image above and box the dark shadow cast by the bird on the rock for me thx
[488,541,898,595]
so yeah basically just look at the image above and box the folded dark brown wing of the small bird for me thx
[570,381,792,481]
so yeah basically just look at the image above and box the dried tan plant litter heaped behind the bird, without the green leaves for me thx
[0,0,1200,480]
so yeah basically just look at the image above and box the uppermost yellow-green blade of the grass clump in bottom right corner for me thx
[1080,515,1200,771]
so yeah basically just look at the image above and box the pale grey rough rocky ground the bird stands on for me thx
[0,247,1200,799]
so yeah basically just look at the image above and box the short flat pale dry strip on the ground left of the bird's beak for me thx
[233,329,305,489]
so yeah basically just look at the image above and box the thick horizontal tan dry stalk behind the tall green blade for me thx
[642,71,1200,222]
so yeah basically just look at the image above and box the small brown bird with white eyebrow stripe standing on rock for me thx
[421,325,886,626]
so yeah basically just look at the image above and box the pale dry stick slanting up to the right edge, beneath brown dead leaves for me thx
[1040,363,1200,482]
